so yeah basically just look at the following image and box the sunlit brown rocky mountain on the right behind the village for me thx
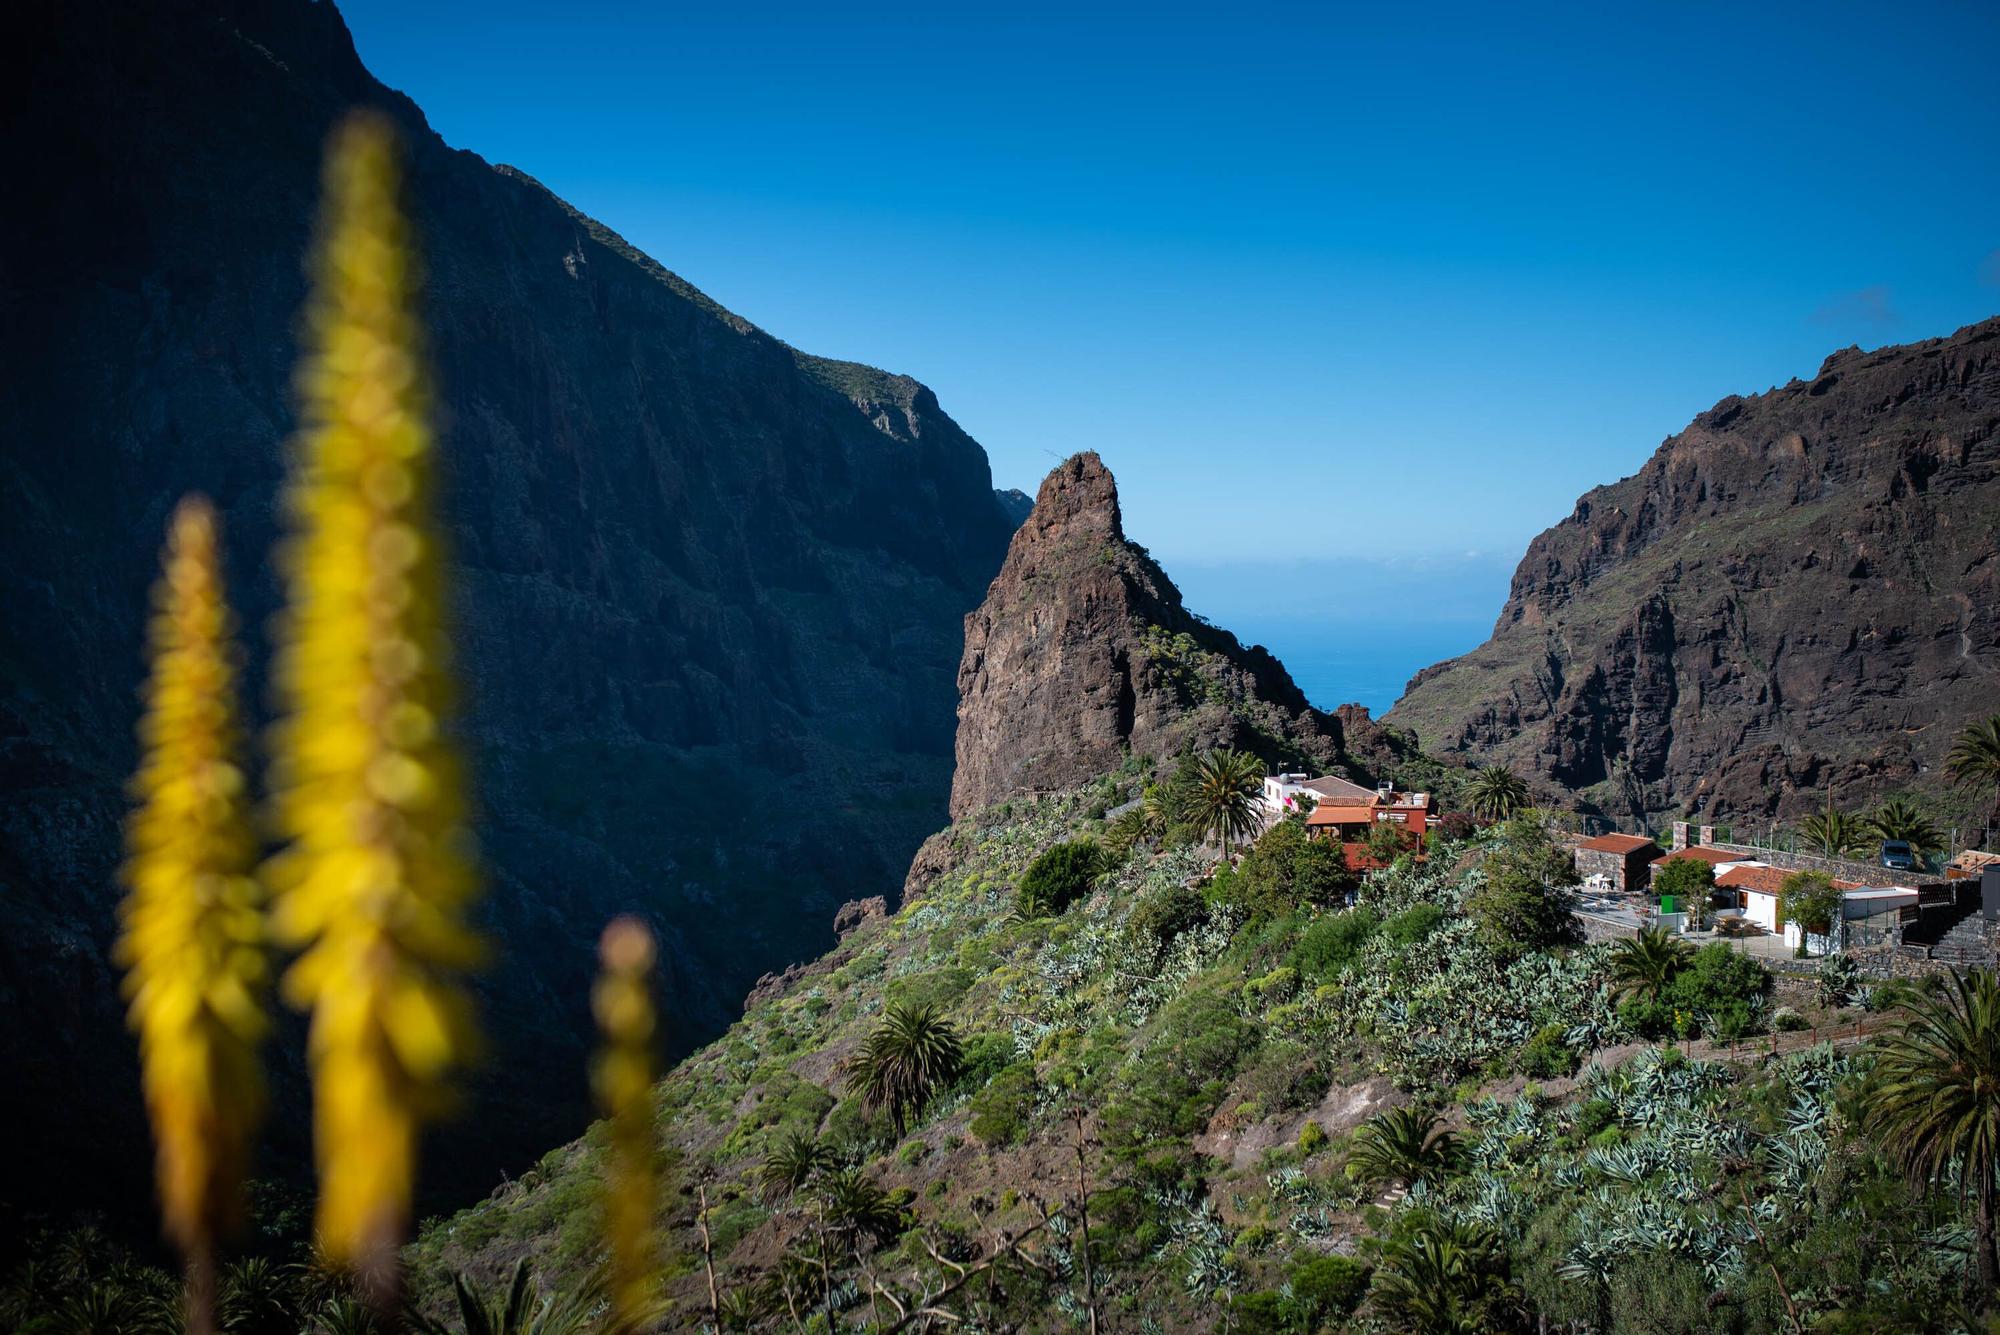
[1388,320,2000,821]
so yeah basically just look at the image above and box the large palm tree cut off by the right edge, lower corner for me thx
[1864,969,2000,1309]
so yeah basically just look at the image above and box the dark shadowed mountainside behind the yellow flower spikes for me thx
[0,0,1012,1213]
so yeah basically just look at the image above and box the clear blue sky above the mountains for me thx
[342,0,2000,707]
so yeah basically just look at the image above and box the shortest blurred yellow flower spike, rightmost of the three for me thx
[590,917,660,1335]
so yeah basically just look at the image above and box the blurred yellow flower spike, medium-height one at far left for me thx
[116,496,268,1331]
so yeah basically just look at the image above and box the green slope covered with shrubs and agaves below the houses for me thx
[378,755,1968,1331]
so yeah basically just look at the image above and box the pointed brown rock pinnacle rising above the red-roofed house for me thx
[952,454,1378,817]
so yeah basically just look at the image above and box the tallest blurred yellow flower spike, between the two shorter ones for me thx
[266,114,482,1301]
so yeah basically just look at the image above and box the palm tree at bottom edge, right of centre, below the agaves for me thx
[1368,1219,1520,1335]
